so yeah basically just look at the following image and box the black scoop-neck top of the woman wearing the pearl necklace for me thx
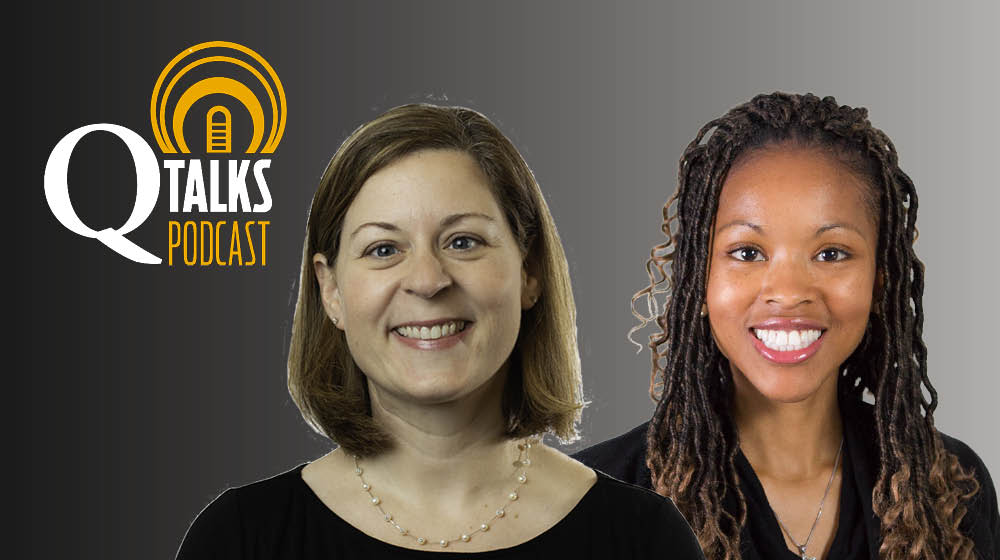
[177,465,704,560]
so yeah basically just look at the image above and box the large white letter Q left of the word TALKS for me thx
[45,123,163,264]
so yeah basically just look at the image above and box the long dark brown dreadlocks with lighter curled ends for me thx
[632,93,979,560]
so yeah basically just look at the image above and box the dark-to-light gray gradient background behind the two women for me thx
[15,1,1000,559]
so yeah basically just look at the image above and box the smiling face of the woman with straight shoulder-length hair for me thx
[313,150,538,404]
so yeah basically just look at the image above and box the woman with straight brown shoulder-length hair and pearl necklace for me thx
[178,105,702,560]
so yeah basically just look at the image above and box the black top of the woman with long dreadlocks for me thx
[574,404,1000,560]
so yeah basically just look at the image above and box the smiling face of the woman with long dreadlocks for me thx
[706,146,878,403]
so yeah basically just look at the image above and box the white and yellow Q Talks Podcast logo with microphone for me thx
[45,41,287,266]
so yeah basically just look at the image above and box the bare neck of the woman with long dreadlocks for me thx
[733,373,843,479]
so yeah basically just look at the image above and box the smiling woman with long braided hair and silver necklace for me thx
[577,93,1000,560]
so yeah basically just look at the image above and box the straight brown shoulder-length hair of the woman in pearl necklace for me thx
[288,104,584,456]
